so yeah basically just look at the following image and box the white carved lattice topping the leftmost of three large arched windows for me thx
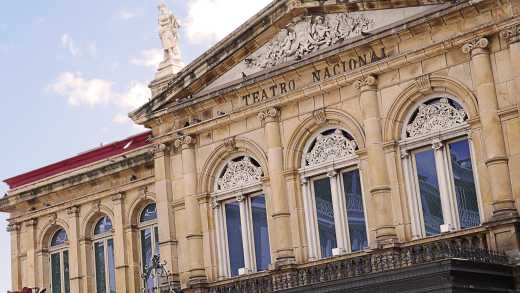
[217,157,263,192]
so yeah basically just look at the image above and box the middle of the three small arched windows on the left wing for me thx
[93,216,116,293]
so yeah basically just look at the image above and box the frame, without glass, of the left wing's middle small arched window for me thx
[91,215,116,293]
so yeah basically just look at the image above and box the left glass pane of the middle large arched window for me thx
[313,177,337,257]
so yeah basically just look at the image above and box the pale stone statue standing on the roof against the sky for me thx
[158,1,181,60]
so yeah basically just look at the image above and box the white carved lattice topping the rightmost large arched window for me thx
[406,98,467,137]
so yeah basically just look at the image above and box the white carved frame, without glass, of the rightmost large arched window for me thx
[398,95,483,239]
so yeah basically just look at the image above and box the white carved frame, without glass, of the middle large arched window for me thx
[298,127,370,260]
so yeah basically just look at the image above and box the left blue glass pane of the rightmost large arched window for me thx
[415,150,444,236]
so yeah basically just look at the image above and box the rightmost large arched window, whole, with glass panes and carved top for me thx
[400,97,480,237]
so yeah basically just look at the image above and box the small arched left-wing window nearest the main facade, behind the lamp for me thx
[139,203,159,293]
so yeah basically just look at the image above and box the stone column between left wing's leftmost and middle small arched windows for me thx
[67,206,84,292]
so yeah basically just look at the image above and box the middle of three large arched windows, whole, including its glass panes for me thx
[299,128,368,259]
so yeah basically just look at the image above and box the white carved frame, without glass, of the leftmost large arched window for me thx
[211,153,273,279]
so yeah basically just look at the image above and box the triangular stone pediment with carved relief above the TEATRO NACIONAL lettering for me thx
[130,0,455,124]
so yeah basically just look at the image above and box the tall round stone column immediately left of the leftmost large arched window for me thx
[175,136,207,287]
